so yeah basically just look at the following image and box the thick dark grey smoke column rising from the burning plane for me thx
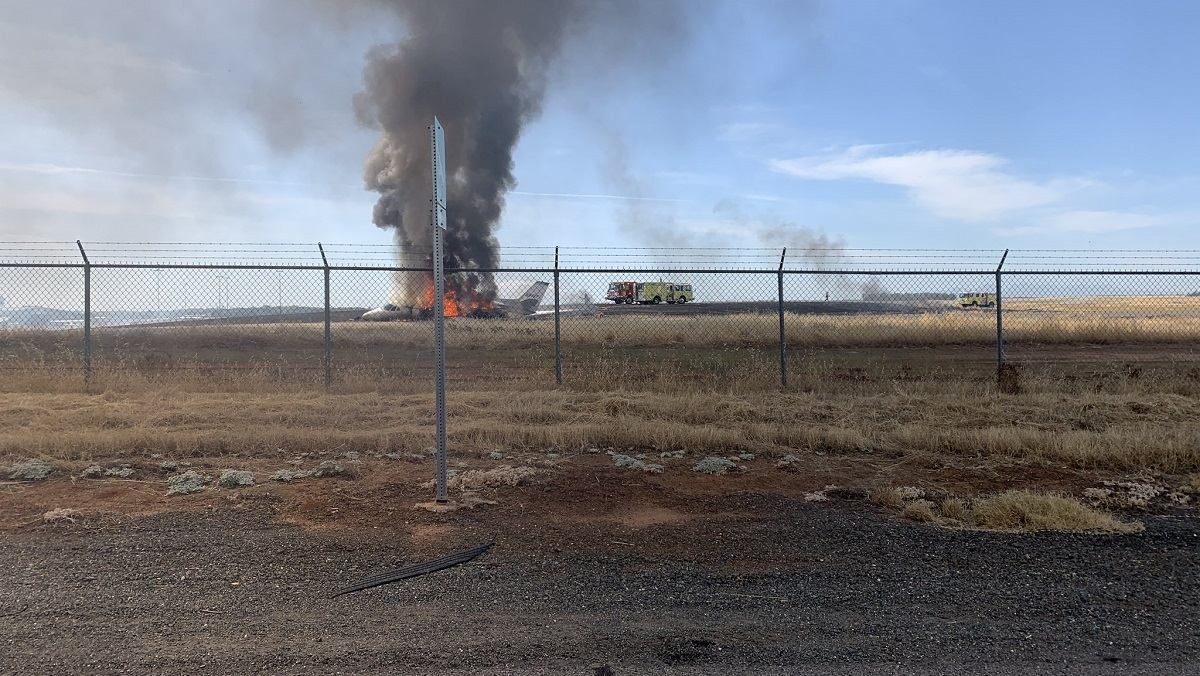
[354,0,583,305]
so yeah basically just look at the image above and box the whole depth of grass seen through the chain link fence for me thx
[0,307,1200,395]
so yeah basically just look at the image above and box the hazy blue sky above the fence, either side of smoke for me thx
[0,0,1200,255]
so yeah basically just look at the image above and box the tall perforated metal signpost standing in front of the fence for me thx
[430,118,450,503]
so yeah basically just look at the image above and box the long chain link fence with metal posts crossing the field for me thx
[0,243,1200,393]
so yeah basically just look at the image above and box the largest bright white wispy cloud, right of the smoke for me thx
[770,145,1087,222]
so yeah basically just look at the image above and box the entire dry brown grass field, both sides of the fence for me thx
[0,299,1200,519]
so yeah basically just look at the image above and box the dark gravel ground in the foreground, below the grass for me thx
[0,493,1200,675]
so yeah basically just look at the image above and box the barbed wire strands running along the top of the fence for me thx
[0,240,1200,274]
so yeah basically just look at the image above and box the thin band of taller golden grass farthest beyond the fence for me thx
[7,297,1200,361]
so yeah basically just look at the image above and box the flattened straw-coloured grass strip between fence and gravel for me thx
[0,389,1200,473]
